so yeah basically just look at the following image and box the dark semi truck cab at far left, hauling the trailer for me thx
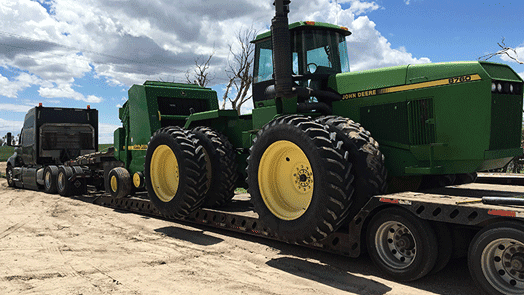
[7,105,98,189]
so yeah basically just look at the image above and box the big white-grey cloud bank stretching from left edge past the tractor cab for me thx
[0,0,429,103]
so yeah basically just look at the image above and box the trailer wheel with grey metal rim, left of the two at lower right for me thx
[366,208,438,281]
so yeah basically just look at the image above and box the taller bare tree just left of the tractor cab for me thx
[222,28,257,114]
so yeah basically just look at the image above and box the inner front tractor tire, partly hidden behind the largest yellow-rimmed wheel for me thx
[315,116,387,224]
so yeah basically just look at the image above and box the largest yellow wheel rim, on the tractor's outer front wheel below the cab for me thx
[258,140,313,220]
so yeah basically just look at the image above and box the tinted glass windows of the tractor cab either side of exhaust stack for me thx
[254,29,349,83]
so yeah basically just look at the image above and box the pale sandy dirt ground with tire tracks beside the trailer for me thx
[0,163,479,295]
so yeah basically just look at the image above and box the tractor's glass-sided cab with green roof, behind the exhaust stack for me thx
[251,21,351,102]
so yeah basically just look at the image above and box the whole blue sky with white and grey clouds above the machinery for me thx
[0,0,524,143]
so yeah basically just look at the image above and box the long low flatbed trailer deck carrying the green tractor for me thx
[93,175,524,257]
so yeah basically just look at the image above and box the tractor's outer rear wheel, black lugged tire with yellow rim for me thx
[144,126,207,218]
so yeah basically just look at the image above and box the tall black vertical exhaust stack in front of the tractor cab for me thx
[271,0,294,98]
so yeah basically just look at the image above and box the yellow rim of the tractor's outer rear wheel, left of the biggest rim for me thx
[149,145,180,203]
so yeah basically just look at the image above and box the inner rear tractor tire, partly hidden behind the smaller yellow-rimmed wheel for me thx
[192,126,238,208]
